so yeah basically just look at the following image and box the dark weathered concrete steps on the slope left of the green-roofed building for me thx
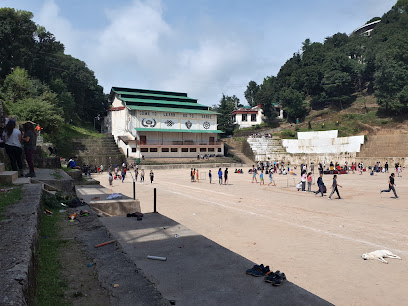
[72,135,126,169]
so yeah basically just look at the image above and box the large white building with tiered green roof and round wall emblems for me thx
[106,87,224,158]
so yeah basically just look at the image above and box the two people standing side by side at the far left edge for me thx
[0,119,37,177]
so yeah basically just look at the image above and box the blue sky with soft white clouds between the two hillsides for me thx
[0,0,396,106]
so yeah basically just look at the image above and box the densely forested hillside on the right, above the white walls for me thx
[245,0,408,122]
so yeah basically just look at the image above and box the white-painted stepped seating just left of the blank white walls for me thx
[247,137,287,161]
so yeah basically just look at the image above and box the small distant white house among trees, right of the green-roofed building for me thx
[231,103,283,129]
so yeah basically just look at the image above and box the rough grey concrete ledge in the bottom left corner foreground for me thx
[0,184,41,305]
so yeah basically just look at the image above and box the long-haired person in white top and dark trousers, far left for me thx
[3,120,24,177]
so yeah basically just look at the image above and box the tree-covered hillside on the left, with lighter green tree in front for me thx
[0,8,107,133]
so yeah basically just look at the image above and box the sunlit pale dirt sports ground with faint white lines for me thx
[94,166,408,305]
